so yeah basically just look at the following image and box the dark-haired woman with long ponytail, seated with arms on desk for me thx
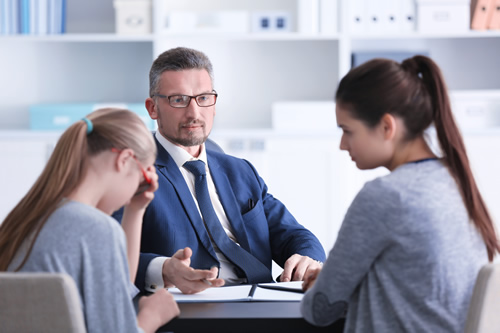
[301,56,500,332]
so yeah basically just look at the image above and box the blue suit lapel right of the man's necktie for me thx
[207,151,252,253]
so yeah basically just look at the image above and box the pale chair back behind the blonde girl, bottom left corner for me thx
[0,272,86,333]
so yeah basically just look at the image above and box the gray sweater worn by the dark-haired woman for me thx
[301,160,488,332]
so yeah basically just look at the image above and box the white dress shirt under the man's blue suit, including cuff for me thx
[145,131,246,292]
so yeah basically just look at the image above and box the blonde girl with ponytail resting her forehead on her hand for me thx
[0,109,179,332]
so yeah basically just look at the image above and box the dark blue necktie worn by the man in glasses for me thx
[184,160,272,283]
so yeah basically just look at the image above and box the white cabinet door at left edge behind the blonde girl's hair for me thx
[0,139,53,223]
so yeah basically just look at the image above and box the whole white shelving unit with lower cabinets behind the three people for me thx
[0,0,500,249]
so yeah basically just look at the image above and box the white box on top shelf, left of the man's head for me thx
[113,0,151,34]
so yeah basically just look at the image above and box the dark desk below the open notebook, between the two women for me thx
[158,302,344,333]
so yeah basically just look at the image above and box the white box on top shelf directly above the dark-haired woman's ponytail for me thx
[417,0,470,33]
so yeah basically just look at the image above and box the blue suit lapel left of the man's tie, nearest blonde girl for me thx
[155,138,218,261]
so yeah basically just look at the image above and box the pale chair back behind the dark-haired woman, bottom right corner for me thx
[465,264,500,333]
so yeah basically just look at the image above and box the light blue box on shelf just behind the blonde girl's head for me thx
[29,103,156,131]
